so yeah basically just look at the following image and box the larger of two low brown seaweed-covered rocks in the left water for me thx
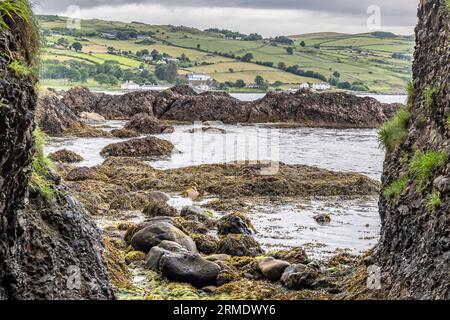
[100,137,174,158]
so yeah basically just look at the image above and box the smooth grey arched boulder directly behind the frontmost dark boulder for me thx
[131,222,197,252]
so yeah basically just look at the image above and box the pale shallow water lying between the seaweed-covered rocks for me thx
[45,99,390,257]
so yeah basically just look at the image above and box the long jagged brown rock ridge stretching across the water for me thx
[41,86,400,130]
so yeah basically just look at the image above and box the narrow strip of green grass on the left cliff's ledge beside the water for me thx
[29,128,55,200]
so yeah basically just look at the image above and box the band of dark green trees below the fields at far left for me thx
[40,60,156,85]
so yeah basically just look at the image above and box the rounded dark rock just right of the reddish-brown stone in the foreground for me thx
[281,264,319,290]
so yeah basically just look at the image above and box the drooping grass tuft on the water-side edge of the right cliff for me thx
[378,107,410,151]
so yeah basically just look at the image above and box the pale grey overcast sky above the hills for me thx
[34,0,418,36]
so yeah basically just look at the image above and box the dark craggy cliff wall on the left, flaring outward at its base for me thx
[0,10,114,300]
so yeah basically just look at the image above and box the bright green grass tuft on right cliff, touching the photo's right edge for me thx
[409,151,448,191]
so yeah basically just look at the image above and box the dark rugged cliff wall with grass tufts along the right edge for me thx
[378,0,450,299]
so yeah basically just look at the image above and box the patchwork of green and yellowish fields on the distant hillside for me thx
[39,16,414,93]
